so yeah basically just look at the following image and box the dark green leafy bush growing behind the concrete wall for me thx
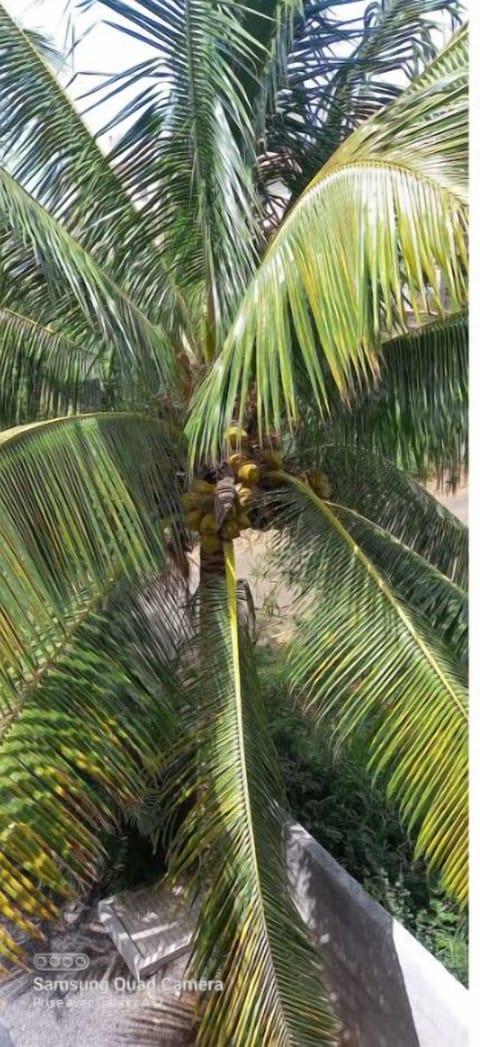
[259,648,467,984]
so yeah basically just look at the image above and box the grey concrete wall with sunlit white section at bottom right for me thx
[287,822,468,1047]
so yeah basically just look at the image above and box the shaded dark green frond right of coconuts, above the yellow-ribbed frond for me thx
[293,443,468,589]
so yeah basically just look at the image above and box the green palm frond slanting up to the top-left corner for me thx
[0,5,197,339]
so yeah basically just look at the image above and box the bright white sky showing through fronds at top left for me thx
[7,0,454,137]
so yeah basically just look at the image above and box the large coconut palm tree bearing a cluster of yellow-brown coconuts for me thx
[0,0,467,1047]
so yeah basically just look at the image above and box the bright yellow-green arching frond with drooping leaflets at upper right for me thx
[189,22,467,454]
